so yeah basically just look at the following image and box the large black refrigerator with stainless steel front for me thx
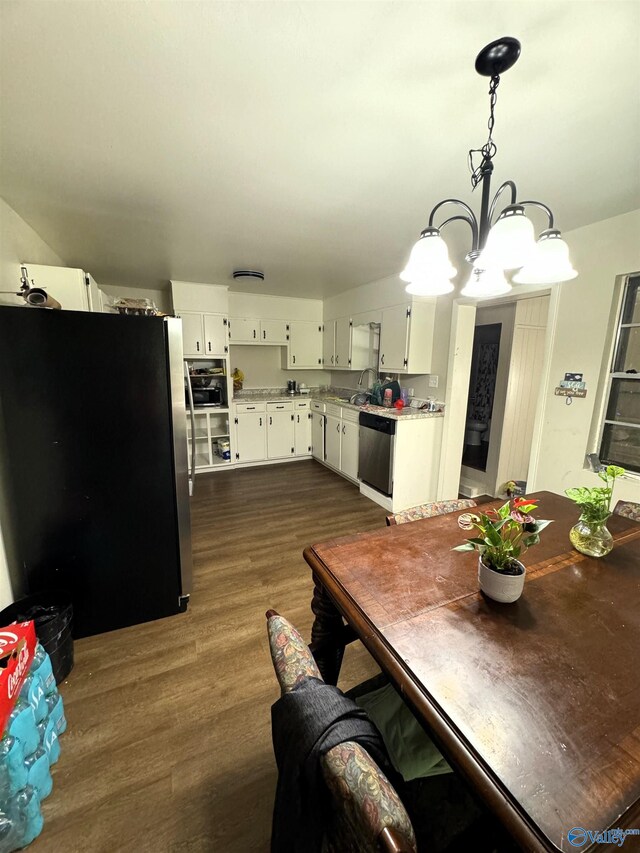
[0,306,191,638]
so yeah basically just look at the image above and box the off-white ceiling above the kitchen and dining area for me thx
[0,0,640,298]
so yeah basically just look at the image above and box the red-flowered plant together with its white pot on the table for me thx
[453,497,551,603]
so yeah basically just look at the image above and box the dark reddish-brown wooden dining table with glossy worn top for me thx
[304,491,640,853]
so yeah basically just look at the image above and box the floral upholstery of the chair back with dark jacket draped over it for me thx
[266,610,417,853]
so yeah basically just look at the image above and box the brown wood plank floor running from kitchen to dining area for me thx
[29,461,385,853]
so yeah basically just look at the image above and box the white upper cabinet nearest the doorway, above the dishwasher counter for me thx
[380,302,435,373]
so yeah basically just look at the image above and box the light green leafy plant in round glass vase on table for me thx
[565,465,625,557]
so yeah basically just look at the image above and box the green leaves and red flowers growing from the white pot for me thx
[453,498,551,574]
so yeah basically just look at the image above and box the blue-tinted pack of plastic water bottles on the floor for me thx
[0,643,67,853]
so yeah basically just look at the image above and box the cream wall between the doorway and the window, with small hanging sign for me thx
[529,210,640,502]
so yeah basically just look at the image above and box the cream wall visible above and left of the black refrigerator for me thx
[0,198,65,609]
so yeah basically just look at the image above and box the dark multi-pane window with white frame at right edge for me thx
[599,275,640,473]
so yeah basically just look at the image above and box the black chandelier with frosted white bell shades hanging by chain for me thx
[400,36,578,297]
